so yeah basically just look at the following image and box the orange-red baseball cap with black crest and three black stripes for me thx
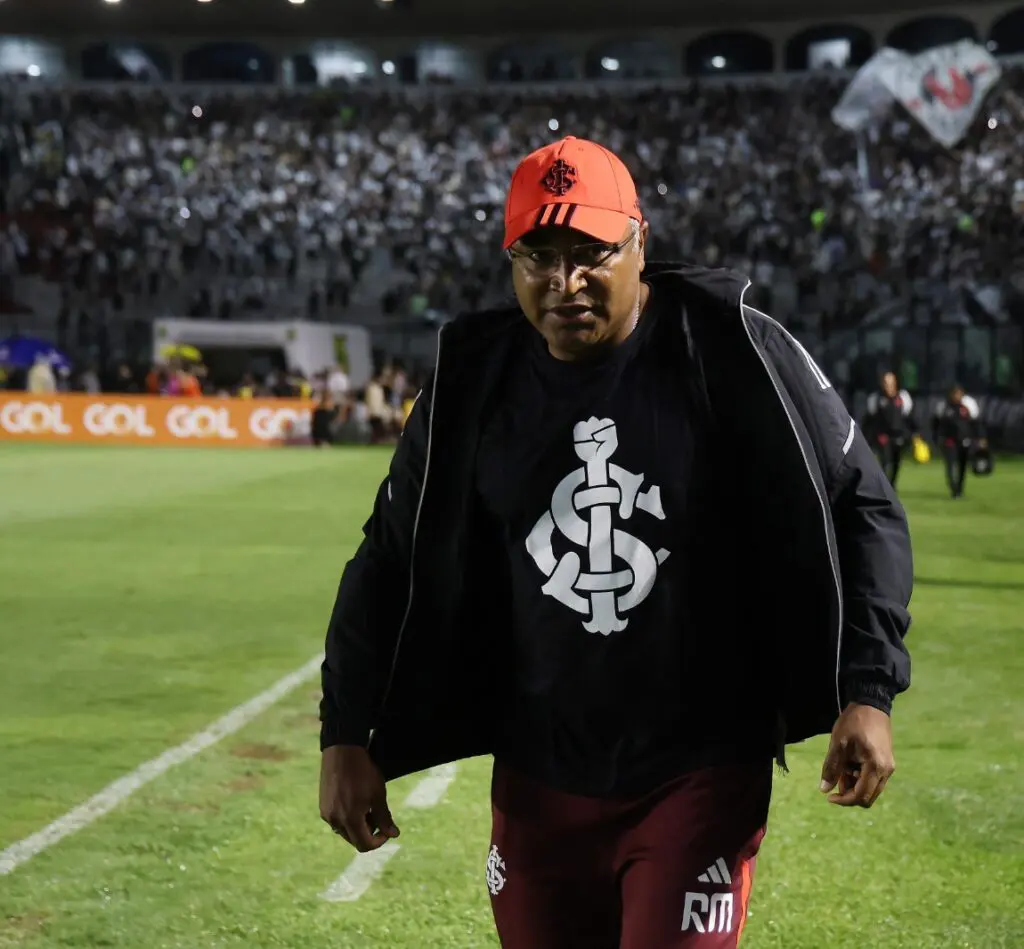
[503,135,643,249]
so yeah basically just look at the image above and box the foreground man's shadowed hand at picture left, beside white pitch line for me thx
[321,744,399,853]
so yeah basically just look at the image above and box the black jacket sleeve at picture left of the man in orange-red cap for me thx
[319,378,432,749]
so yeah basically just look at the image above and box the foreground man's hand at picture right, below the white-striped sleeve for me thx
[821,703,896,808]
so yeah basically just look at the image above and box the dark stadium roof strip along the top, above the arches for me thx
[0,0,958,39]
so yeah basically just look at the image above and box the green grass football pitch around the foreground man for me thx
[0,446,1024,949]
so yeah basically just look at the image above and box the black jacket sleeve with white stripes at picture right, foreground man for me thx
[765,321,913,713]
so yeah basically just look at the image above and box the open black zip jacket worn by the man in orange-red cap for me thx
[321,265,912,779]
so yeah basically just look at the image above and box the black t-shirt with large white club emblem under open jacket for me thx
[477,286,770,796]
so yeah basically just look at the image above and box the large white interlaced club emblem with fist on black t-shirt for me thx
[526,418,669,636]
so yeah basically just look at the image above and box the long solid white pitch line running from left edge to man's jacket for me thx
[0,654,324,876]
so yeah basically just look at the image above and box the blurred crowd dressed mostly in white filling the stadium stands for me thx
[0,70,1024,384]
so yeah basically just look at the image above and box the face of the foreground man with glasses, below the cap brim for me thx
[511,223,647,360]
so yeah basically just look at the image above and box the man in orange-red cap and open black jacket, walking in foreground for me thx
[321,137,912,949]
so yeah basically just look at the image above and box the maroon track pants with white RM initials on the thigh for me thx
[486,761,772,949]
